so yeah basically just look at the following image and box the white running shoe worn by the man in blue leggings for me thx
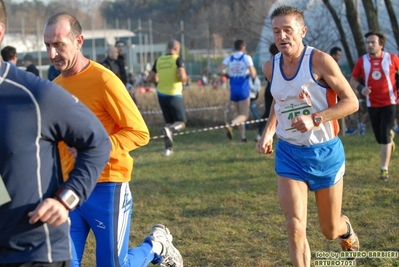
[150,224,183,267]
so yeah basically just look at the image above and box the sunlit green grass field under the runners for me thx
[83,87,399,267]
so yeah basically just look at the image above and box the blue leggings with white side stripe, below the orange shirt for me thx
[70,182,158,267]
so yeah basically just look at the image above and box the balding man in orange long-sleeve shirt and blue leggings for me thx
[44,13,183,267]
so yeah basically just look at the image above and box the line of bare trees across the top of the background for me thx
[5,0,399,72]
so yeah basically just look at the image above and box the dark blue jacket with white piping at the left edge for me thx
[0,62,111,264]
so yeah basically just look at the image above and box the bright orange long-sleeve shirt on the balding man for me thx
[54,61,150,182]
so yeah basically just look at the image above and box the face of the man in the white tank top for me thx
[272,15,307,54]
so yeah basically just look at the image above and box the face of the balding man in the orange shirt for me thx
[44,19,83,72]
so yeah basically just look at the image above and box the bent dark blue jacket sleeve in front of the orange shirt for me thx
[40,82,111,203]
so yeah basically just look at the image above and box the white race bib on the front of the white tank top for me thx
[280,102,314,137]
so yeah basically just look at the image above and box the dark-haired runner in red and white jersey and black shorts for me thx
[350,32,399,181]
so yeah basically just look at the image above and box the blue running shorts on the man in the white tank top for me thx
[275,137,345,191]
